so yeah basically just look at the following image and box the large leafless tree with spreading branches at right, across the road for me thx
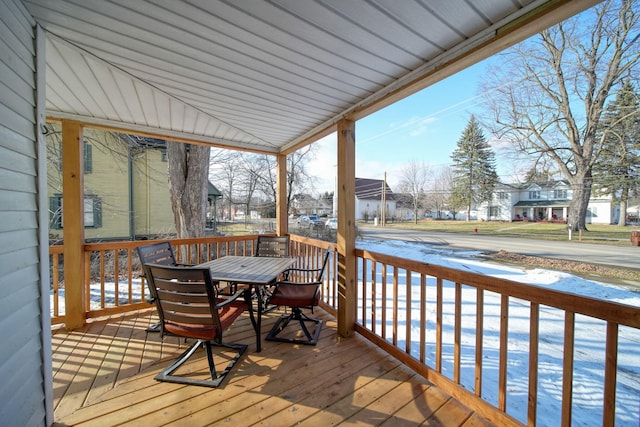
[488,0,640,231]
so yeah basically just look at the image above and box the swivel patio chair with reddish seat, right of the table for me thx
[266,251,331,345]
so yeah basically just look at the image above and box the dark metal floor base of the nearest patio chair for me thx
[155,340,247,388]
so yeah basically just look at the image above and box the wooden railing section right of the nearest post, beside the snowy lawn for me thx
[356,250,640,426]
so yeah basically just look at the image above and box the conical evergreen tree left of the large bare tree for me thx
[450,116,498,221]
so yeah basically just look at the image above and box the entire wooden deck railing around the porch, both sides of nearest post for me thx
[50,235,640,426]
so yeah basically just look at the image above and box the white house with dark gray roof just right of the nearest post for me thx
[355,178,396,221]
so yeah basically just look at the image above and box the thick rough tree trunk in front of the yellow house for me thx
[167,141,210,244]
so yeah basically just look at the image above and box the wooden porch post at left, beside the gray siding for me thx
[62,120,85,330]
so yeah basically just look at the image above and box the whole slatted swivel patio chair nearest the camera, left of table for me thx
[146,264,251,387]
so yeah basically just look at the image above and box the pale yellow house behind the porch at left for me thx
[47,129,222,241]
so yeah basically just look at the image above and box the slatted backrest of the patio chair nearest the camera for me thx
[146,264,223,340]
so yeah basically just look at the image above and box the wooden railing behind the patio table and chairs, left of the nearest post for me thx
[49,234,337,325]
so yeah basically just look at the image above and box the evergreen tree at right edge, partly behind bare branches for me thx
[593,80,640,225]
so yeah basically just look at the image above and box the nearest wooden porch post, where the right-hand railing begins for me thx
[334,120,358,337]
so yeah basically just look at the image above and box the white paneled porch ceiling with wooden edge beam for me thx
[24,0,597,153]
